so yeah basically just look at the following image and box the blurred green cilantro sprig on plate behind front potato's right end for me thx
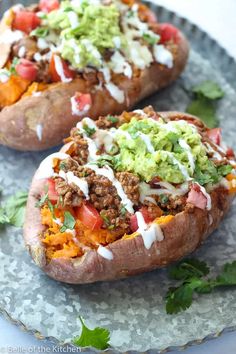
[186,81,224,128]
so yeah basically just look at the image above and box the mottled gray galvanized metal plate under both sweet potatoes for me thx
[0,1,236,352]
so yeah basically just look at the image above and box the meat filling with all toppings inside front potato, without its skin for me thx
[37,107,236,260]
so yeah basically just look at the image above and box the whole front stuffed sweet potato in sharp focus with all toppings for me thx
[24,107,236,284]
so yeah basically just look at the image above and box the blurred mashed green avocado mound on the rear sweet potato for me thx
[48,1,122,69]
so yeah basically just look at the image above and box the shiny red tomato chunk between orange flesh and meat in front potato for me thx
[75,203,103,230]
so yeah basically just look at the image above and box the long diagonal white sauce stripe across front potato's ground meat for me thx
[86,164,134,214]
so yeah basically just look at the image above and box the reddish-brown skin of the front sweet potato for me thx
[24,112,233,284]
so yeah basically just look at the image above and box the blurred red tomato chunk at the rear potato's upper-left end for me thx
[12,11,41,34]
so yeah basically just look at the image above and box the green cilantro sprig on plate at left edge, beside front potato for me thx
[0,192,28,227]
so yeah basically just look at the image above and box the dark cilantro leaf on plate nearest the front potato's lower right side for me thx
[169,258,209,280]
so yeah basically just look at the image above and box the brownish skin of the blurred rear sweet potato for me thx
[0,32,189,151]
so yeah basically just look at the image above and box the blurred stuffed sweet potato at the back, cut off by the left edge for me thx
[0,0,188,150]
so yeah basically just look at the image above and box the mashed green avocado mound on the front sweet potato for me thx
[111,118,232,185]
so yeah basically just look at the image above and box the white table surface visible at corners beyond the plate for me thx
[0,0,236,354]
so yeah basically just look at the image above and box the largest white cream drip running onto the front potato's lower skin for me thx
[135,211,164,250]
